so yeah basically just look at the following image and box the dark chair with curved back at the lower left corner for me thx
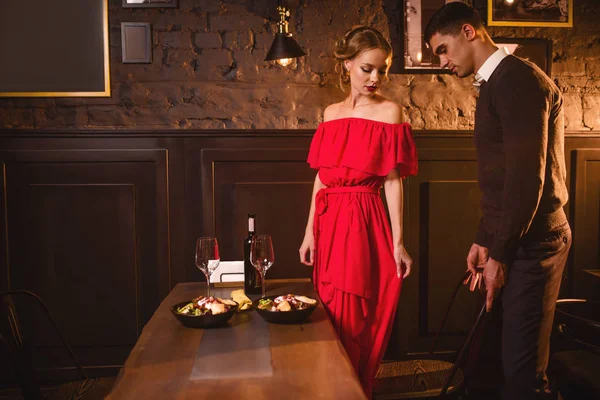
[0,290,115,400]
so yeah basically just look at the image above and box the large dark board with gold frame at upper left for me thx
[0,0,111,97]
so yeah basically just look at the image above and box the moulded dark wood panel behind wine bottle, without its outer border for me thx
[202,148,315,278]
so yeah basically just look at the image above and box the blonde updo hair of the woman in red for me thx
[333,26,392,89]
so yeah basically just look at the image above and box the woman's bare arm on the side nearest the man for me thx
[383,168,412,278]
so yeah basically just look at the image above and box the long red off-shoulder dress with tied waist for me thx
[308,118,417,398]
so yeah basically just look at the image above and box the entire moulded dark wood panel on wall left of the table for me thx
[0,150,170,376]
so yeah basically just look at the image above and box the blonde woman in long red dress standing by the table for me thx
[300,26,417,398]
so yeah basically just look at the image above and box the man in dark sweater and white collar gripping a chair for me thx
[425,2,571,399]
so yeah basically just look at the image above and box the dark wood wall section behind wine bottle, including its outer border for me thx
[184,136,315,281]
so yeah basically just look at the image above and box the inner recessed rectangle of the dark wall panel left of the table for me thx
[17,184,140,346]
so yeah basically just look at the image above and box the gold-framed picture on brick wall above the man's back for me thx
[488,0,573,28]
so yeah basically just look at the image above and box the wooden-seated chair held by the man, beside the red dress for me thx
[373,271,486,400]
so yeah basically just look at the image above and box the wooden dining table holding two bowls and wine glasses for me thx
[108,280,366,400]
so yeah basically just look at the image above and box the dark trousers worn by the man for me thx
[500,223,571,400]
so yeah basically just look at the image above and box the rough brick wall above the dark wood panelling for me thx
[0,0,600,131]
